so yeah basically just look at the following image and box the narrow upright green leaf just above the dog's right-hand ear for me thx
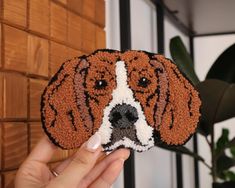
[170,36,199,85]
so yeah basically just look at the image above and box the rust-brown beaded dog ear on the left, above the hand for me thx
[41,58,92,149]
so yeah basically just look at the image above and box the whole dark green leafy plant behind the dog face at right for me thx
[164,36,235,186]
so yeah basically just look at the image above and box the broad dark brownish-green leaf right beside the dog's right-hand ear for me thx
[196,79,235,135]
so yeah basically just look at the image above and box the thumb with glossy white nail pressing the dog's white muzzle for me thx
[48,134,102,187]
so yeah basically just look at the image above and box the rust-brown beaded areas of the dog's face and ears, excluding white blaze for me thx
[41,50,201,149]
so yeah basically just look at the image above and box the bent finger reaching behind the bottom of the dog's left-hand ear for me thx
[26,136,57,163]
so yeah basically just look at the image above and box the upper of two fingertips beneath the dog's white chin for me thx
[80,149,130,187]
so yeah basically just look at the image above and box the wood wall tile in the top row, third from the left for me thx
[51,2,67,41]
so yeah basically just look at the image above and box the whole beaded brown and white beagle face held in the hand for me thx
[41,50,201,152]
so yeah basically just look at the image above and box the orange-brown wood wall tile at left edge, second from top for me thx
[3,25,28,72]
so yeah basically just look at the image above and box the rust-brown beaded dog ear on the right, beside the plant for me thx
[154,55,201,145]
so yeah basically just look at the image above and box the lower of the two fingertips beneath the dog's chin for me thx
[89,159,124,188]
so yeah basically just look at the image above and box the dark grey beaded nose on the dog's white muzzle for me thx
[109,104,138,128]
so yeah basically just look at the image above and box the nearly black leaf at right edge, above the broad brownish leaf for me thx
[206,44,235,83]
